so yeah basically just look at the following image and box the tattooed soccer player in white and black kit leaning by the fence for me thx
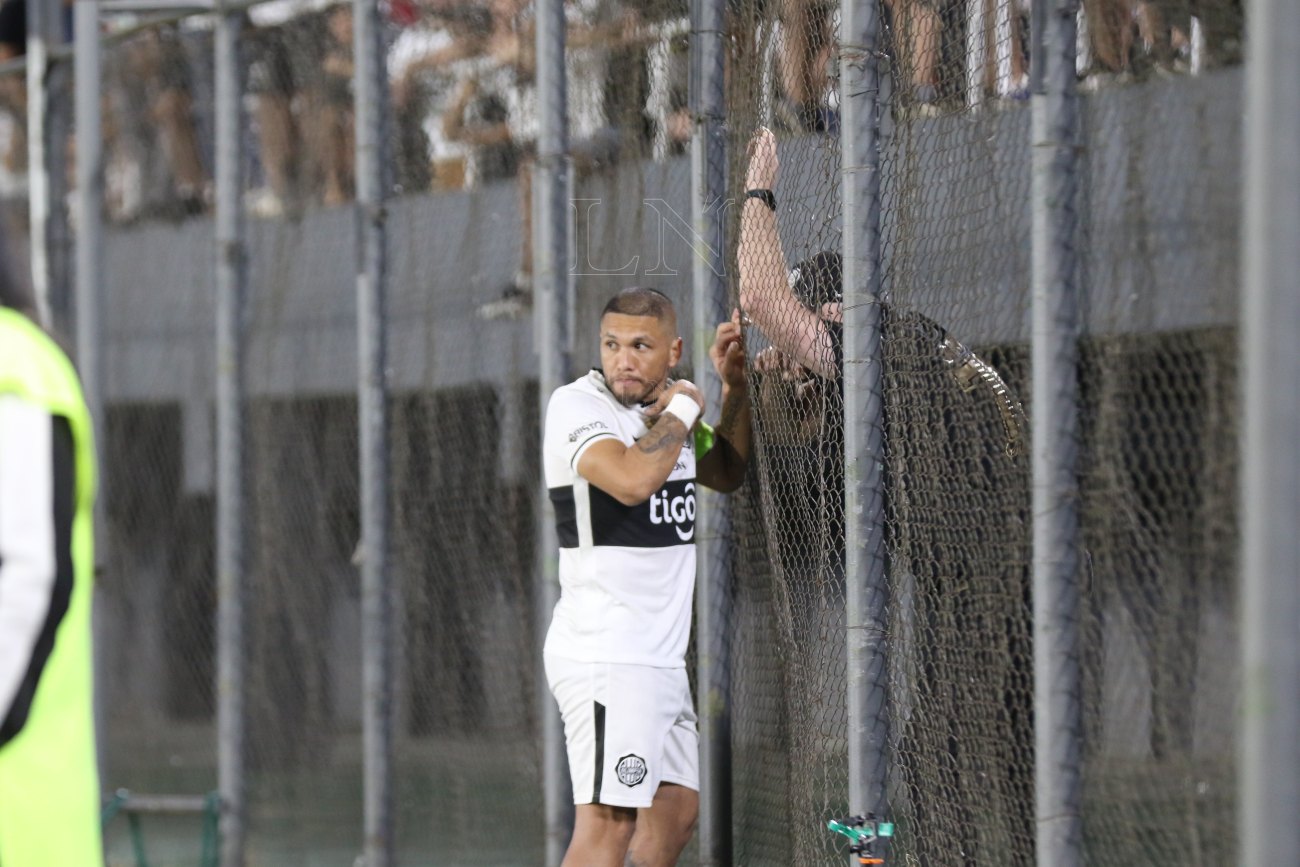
[542,287,750,867]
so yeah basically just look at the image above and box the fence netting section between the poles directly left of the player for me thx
[387,3,542,842]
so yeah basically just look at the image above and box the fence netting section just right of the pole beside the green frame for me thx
[239,3,361,863]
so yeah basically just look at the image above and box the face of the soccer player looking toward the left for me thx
[601,313,681,407]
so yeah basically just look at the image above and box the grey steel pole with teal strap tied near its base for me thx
[840,0,889,842]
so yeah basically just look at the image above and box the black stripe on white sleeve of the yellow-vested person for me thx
[0,416,77,746]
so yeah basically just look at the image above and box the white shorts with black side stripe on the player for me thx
[545,655,699,807]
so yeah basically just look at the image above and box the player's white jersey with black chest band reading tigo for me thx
[542,370,696,668]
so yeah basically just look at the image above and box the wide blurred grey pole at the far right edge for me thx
[1236,0,1300,864]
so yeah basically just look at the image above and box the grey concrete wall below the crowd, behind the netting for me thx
[104,70,1242,415]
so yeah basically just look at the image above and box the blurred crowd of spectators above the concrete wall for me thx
[0,0,1243,227]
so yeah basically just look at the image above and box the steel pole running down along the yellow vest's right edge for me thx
[73,0,108,777]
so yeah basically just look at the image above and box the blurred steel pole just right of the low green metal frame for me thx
[213,12,248,867]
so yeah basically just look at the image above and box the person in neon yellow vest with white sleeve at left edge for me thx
[0,284,104,867]
